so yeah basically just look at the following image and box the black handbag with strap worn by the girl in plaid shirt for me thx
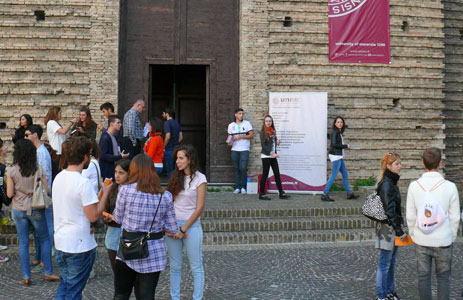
[117,195,163,260]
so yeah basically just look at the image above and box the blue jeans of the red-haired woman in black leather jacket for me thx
[376,246,398,299]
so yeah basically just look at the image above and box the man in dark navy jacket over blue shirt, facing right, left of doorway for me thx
[100,115,130,178]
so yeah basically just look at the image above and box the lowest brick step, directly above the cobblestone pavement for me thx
[203,228,375,245]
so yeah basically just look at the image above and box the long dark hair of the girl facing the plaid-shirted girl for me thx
[167,145,199,198]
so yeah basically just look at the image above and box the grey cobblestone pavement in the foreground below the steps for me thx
[0,239,463,300]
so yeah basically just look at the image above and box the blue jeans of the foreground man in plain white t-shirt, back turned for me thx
[55,248,96,300]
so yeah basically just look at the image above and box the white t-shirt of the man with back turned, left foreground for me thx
[53,170,98,253]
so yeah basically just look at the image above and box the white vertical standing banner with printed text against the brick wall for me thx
[268,92,328,192]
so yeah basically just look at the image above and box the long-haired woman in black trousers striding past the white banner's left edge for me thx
[259,115,290,201]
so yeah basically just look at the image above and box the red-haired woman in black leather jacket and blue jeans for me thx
[375,152,408,300]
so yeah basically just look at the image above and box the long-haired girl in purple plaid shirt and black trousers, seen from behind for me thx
[114,154,178,300]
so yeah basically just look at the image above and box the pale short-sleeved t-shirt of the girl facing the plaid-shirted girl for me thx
[174,171,207,221]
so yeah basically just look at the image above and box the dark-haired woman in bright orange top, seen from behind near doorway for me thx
[144,118,164,175]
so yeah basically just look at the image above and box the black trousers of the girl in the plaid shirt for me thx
[114,260,161,300]
